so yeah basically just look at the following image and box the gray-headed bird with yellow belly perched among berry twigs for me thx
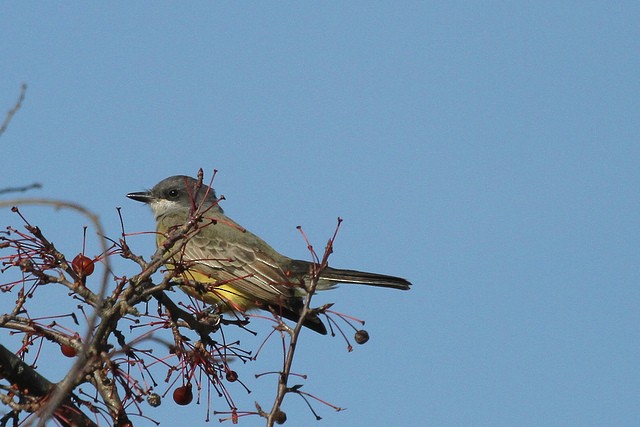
[127,175,411,335]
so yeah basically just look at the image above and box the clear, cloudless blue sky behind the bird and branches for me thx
[0,1,640,427]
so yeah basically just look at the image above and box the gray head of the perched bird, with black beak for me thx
[127,175,222,219]
